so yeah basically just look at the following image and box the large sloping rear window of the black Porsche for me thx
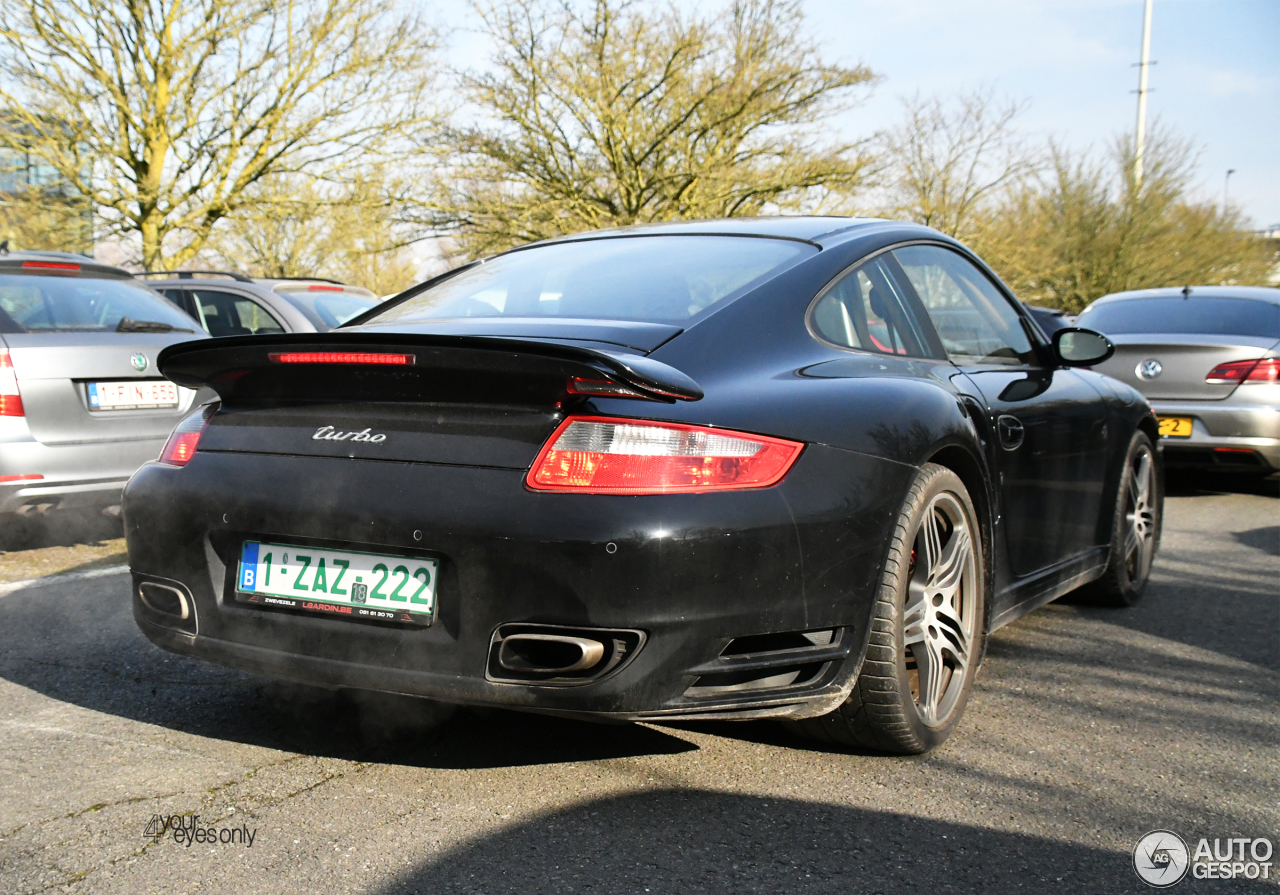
[366,236,817,324]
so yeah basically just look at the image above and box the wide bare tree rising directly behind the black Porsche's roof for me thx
[431,0,873,256]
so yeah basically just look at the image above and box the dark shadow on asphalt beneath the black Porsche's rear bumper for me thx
[0,575,698,768]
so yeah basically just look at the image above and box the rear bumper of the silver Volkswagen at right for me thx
[1151,401,1280,471]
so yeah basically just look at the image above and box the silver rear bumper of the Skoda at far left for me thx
[0,438,165,515]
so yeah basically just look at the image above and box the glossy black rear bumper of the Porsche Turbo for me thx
[124,446,915,720]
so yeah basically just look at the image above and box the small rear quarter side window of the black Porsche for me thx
[809,259,927,357]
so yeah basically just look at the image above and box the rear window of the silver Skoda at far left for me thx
[0,274,200,333]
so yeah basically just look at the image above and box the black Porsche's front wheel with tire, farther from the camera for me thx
[1084,431,1165,608]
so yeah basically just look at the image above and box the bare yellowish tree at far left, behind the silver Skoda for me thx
[0,0,436,268]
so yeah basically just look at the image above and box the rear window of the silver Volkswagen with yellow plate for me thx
[1075,296,1280,339]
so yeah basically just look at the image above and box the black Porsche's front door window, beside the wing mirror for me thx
[893,246,1036,366]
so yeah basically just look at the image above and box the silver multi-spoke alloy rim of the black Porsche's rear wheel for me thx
[902,492,979,727]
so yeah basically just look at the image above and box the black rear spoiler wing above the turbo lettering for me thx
[156,330,703,402]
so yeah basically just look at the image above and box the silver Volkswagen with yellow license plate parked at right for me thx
[1076,286,1280,475]
